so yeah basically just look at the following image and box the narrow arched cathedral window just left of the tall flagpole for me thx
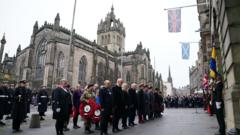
[57,52,64,79]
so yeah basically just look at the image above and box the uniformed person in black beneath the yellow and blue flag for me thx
[213,81,225,135]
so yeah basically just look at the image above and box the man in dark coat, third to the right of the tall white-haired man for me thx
[137,84,145,123]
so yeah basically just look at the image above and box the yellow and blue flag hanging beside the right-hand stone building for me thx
[210,46,217,78]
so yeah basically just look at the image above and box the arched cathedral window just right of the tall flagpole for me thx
[78,56,87,82]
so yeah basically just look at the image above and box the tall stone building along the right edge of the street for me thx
[197,0,240,132]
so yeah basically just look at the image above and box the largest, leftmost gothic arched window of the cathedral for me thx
[35,40,47,80]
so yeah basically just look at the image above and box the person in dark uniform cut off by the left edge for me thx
[0,85,7,126]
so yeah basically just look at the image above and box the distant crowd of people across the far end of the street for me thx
[164,94,204,108]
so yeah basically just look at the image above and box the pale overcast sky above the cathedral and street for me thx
[0,0,200,88]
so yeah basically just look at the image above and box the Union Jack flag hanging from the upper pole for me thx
[168,9,181,32]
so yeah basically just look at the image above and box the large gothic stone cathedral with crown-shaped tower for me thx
[2,7,163,88]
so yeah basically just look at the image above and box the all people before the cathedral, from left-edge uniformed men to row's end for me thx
[0,79,164,135]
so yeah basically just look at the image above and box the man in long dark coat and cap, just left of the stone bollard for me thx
[12,80,27,133]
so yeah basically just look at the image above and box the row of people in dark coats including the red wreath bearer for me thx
[52,79,163,135]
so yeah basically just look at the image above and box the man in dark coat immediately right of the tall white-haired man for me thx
[122,83,129,129]
